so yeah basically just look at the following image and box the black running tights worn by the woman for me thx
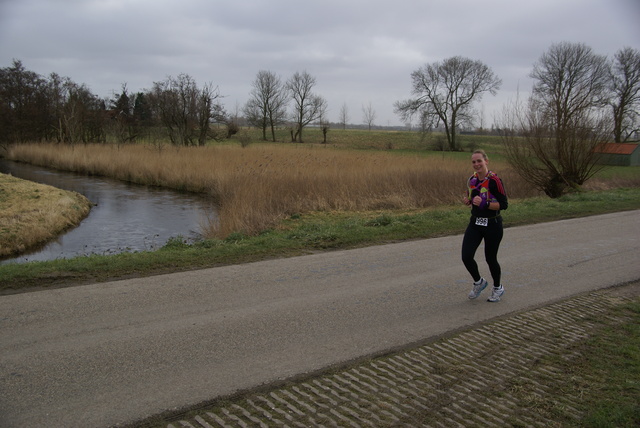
[462,218,503,287]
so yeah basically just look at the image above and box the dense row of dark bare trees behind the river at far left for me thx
[0,60,228,146]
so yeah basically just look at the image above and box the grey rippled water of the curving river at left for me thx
[0,159,215,264]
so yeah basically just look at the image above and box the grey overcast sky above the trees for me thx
[0,0,640,126]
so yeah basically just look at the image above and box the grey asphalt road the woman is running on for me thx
[0,211,640,427]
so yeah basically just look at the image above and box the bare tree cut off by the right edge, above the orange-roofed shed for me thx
[609,47,640,143]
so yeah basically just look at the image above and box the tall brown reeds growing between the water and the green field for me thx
[8,144,537,237]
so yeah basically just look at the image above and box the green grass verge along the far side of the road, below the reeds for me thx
[0,188,640,294]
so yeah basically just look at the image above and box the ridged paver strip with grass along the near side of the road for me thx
[159,282,640,428]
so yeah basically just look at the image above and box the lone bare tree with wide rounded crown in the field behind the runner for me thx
[395,56,502,150]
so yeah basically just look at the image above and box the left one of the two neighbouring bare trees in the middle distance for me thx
[244,70,289,141]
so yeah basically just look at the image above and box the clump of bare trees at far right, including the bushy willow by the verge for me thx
[502,42,640,197]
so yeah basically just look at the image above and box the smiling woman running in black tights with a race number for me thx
[462,150,508,302]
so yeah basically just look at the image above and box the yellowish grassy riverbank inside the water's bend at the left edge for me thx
[0,174,92,257]
